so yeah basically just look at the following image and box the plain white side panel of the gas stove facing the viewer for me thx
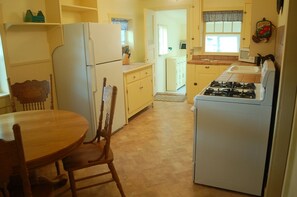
[194,97,271,195]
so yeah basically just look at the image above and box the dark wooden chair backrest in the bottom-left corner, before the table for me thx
[0,124,32,197]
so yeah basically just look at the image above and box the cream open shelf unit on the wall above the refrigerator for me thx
[57,0,98,24]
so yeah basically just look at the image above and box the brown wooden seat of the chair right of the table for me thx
[63,142,113,171]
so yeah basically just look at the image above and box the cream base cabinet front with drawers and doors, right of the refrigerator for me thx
[124,65,153,122]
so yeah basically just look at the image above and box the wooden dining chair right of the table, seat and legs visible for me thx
[62,78,125,196]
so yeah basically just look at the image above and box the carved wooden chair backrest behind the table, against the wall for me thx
[7,75,54,112]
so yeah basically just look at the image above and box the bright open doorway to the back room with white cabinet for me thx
[155,9,187,94]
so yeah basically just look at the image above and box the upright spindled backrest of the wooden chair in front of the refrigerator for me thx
[91,78,117,157]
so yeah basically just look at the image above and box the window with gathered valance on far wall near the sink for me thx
[203,11,242,53]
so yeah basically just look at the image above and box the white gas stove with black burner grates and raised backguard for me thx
[193,61,275,196]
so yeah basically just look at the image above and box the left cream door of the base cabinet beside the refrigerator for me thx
[127,81,142,114]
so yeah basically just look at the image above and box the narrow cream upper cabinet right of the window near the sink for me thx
[242,0,252,48]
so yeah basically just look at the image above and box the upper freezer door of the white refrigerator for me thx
[86,23,122,65]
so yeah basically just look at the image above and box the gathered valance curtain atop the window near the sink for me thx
[203,10,243,22]
